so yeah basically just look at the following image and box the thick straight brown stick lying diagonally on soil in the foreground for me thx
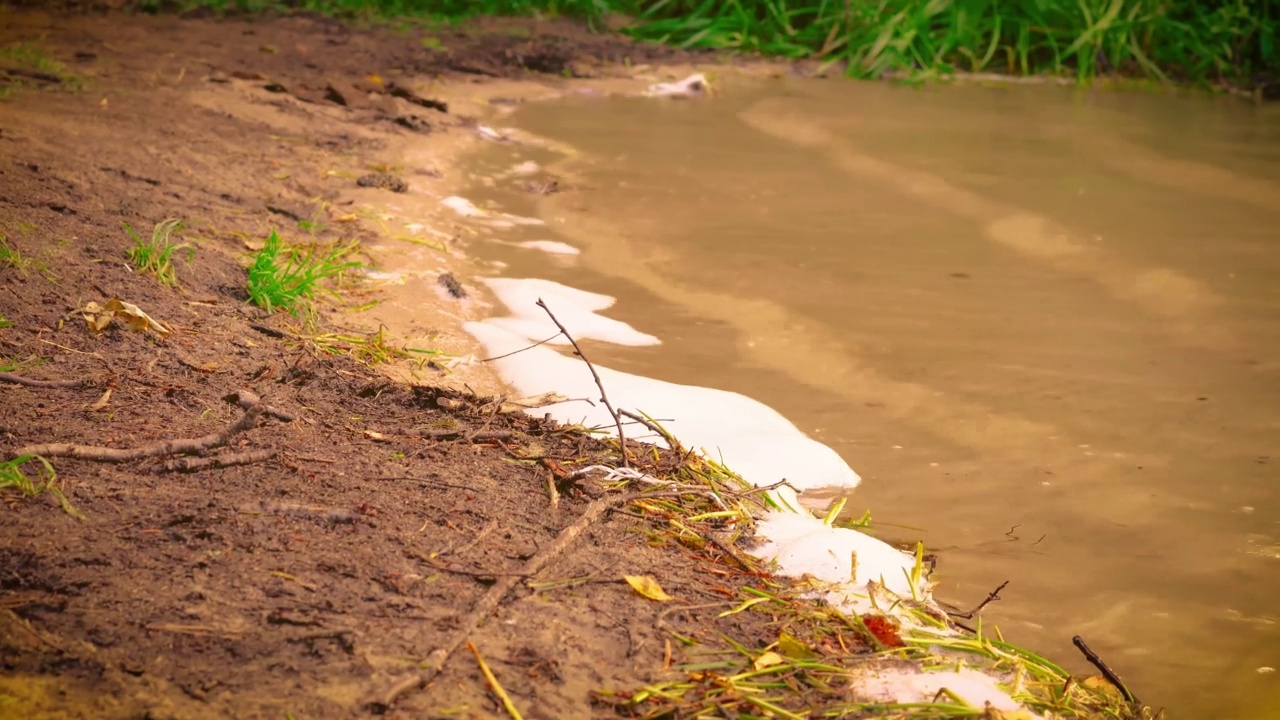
[371,493,644,711]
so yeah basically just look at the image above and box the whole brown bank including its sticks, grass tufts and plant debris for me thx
[0,5,1144,720]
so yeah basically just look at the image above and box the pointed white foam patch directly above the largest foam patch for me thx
[484,278,662,345]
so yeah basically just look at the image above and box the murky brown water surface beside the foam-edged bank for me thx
[463,81,1280,719]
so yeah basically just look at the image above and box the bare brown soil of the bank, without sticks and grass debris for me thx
[0,10,798,719]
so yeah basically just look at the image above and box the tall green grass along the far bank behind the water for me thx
[630,0,1280,83]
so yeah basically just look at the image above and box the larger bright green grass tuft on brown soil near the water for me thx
[246,231,360,315]
